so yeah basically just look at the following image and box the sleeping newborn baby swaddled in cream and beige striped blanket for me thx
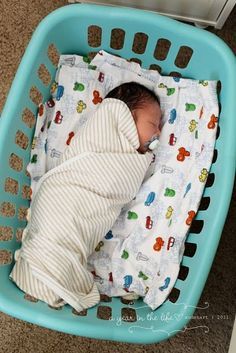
[10,82,161,312]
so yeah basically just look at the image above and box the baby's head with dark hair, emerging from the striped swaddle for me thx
[106,82,161,153]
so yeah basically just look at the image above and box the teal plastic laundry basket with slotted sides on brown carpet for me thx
[0,4,236,344]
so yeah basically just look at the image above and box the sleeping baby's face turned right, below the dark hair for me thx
[132,102,161,153]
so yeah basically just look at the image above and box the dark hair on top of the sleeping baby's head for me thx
[105,82,160,111]
